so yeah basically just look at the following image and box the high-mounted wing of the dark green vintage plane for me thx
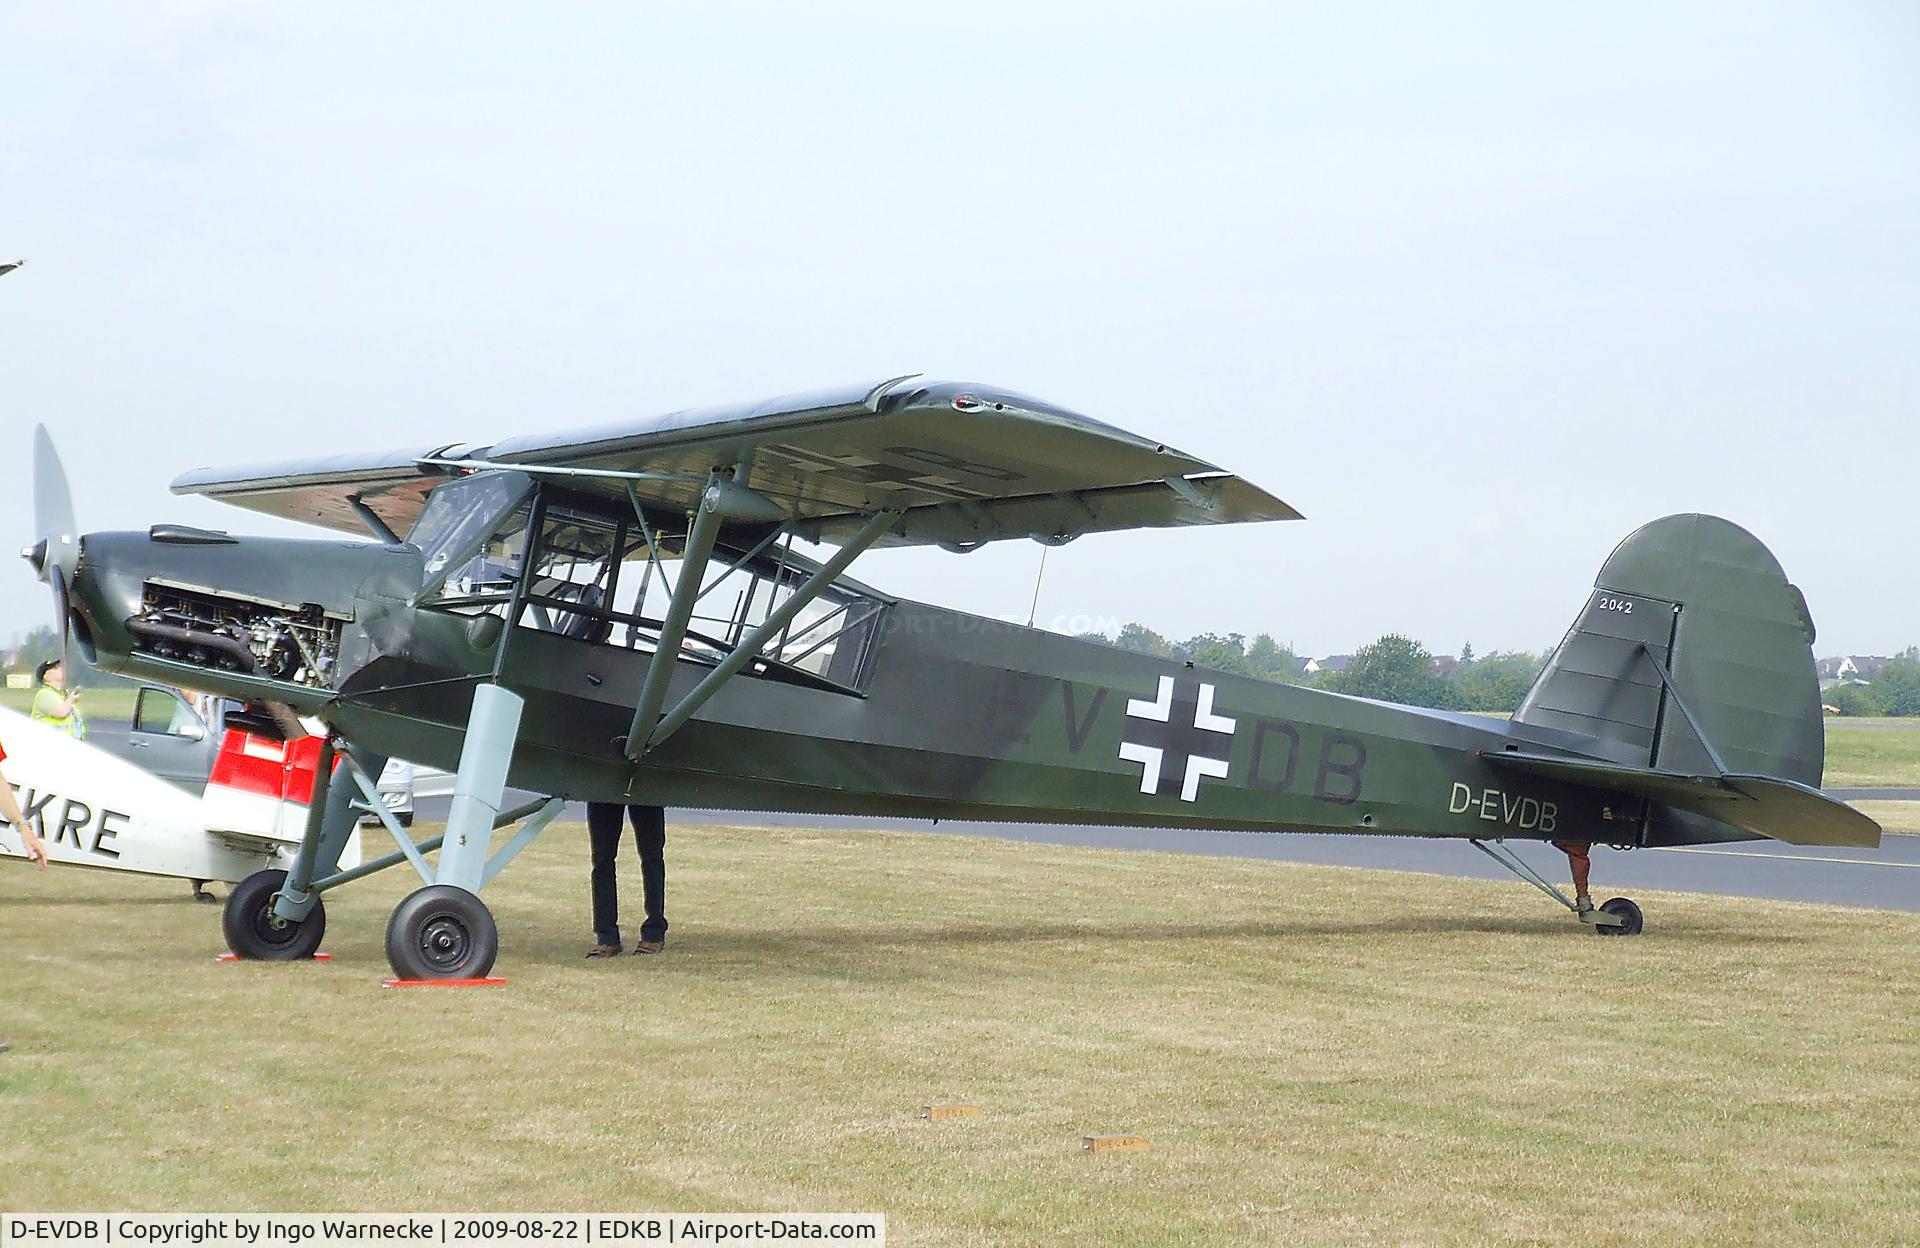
[173,376,1300,549]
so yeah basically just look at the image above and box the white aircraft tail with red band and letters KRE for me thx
[0,708,361,883]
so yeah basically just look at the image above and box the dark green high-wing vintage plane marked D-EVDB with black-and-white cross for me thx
[11,376,1880,977]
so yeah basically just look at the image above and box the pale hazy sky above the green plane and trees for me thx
[0,2,1920,655]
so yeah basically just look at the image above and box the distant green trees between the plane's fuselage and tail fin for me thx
[1081,624,1546,714]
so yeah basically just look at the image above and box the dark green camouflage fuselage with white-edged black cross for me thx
[77,534,1651,843]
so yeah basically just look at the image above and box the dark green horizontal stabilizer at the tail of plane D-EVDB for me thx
[1480,751,1880,849]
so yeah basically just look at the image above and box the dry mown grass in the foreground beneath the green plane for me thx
[0,826,1920,1246]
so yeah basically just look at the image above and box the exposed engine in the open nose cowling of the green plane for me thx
[127,582,346,687]
